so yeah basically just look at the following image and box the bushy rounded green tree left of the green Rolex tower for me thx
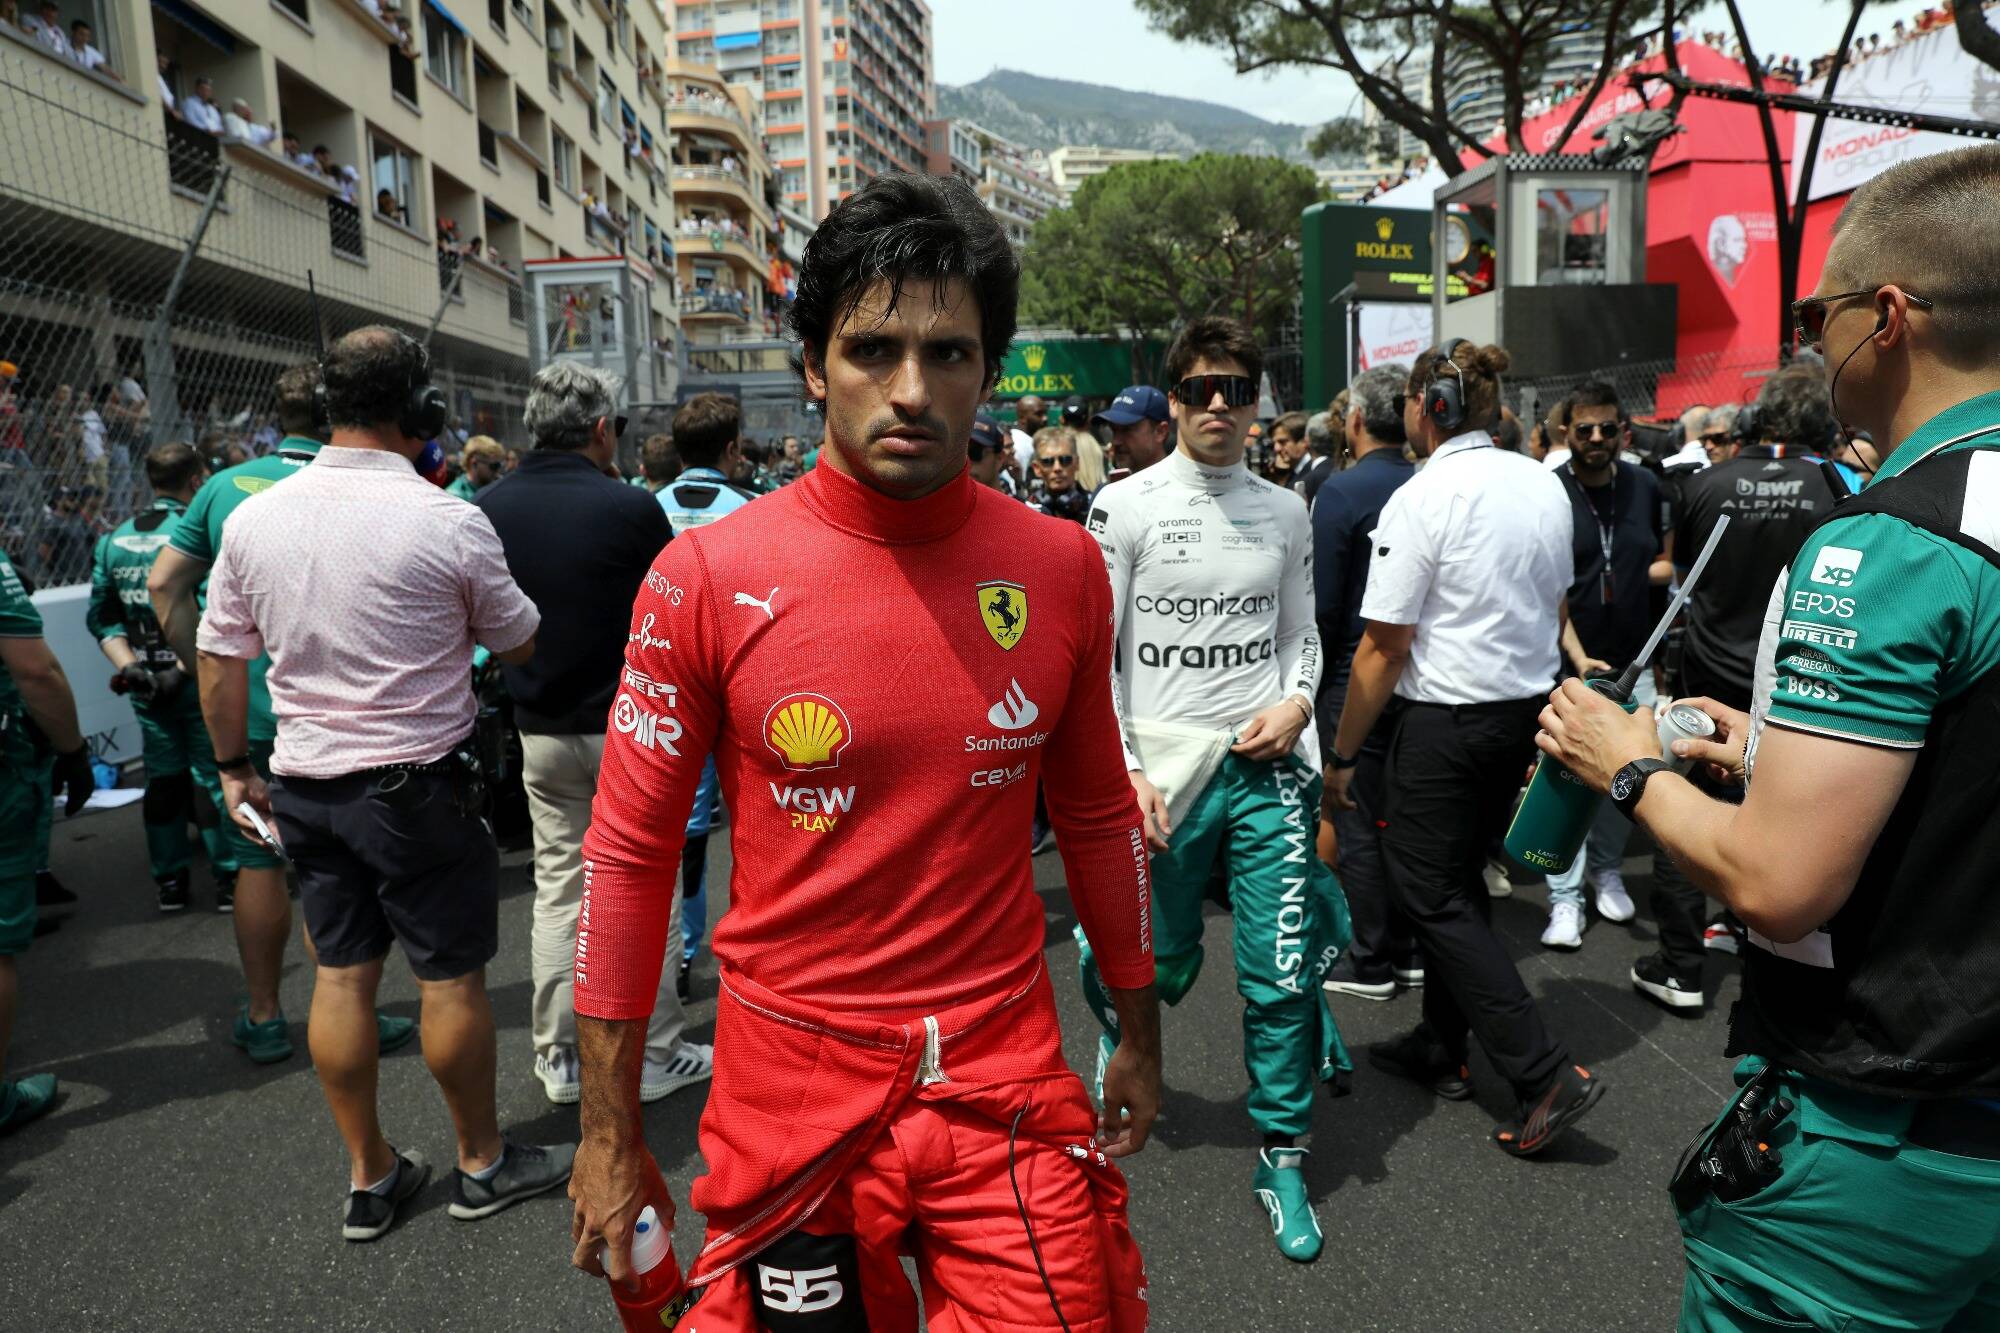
[1022,152,1324,350]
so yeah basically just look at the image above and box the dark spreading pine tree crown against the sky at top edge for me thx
[1136,0,1686,176]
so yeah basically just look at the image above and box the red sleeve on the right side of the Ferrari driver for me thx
[1042,524,1152,991]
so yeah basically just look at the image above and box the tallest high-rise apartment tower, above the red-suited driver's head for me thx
[674,0,936,220]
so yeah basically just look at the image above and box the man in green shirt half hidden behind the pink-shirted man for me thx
[146,364,416,1065]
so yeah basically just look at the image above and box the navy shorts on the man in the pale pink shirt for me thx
[270,756,500,981]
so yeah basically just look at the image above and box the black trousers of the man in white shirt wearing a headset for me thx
[1382,697,1568,1101]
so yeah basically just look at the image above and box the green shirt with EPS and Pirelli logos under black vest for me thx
[1758,392,2000,749]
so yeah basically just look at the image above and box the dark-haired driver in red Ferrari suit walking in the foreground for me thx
[570,176,1160,1333]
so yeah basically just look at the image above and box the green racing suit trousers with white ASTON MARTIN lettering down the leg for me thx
[1078,755,1354,1135]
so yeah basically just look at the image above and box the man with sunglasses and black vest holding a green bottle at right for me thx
[1538,146,2000,1329]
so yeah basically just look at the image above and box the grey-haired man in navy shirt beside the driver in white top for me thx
[1312,364,1424,1001]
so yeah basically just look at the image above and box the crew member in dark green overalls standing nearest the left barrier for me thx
[84,442,236,913]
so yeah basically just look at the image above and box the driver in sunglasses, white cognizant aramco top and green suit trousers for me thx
[1082,318,1348,1263]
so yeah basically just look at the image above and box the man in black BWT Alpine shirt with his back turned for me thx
[1632,368,1836,992]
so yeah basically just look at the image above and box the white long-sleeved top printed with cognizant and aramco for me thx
[1086,450,1320,756]
